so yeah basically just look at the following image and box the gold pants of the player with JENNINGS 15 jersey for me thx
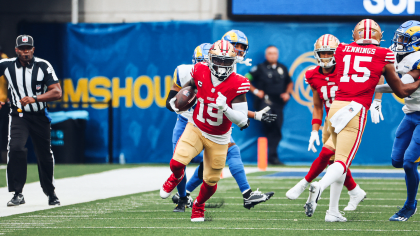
[327,100,367,170]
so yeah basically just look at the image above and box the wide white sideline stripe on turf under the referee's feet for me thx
[0,165,258,217]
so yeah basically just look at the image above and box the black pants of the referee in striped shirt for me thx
[7,108,55,196]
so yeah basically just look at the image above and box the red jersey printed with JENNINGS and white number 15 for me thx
[334,43,395,109]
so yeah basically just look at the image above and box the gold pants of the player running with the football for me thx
[173,123,228,186]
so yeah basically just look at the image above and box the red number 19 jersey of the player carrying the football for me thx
[192,62,250,135]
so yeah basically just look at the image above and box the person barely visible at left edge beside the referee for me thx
[0,45,9,163]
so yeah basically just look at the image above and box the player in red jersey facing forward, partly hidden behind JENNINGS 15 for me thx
[286,34,366,211]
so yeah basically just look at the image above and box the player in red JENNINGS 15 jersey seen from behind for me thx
[305,19,420,222]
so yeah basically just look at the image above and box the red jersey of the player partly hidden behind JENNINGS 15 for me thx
[305,66,338,115]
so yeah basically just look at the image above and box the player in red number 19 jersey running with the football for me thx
[160,40,250,222]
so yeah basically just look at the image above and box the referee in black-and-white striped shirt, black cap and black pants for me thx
[0,35,62,206]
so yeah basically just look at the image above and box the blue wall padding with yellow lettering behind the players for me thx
[19,21,404,165]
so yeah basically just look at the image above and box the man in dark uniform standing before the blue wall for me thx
[245,46,293,165]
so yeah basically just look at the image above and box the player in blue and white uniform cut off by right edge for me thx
[376,20,420,221]
